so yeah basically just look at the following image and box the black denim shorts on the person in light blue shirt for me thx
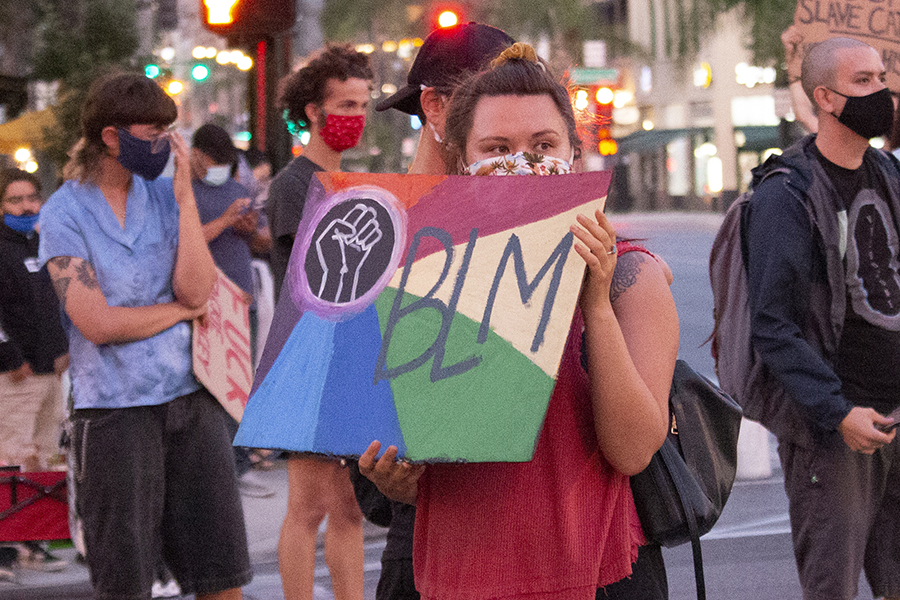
[71,388,251,600]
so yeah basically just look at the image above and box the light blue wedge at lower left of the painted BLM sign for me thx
[234,312,338,452]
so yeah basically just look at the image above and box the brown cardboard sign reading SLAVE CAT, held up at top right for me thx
[794,0,900,91]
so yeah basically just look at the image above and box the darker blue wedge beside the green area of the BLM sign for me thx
[312,305,406,456]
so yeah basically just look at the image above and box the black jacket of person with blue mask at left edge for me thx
[0,220,68,374]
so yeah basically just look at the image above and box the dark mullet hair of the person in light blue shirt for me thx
[63,72,178,180]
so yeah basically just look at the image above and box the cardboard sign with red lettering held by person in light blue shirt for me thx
[193,269,253,421]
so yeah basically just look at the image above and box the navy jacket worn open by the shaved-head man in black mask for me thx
[746,135,900,445]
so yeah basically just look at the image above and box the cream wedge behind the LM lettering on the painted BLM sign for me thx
[389,204,605,378]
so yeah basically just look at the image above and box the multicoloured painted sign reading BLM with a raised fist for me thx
[235,173,609,462]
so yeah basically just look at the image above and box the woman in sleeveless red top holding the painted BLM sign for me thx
[359,44,678,599]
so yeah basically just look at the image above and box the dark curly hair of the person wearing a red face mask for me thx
[278,44,375,131]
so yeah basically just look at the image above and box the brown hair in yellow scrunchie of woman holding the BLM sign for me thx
[444,42,581,174]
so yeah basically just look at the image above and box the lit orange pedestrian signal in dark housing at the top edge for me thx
[199,0,297,39]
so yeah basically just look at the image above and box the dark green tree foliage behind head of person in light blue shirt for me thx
[33,0,139,165]
